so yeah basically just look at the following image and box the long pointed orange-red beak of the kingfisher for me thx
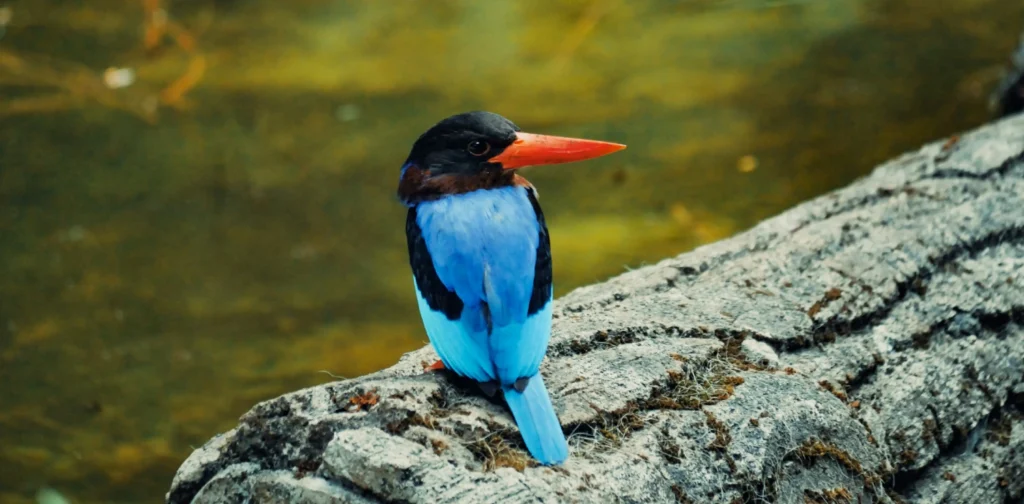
[487,132,626,170]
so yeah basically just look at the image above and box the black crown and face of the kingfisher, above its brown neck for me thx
[406,112,519,176]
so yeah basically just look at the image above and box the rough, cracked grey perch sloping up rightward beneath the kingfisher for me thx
[166,116,1024,504]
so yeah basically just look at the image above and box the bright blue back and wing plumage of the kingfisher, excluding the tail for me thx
[414,186,551,386]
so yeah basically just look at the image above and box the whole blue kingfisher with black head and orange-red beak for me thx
[397,111,626,465]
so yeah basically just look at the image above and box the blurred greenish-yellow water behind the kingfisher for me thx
[0,0,1024,503]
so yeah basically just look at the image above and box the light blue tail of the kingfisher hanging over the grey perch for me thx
[505,373,569,465]
